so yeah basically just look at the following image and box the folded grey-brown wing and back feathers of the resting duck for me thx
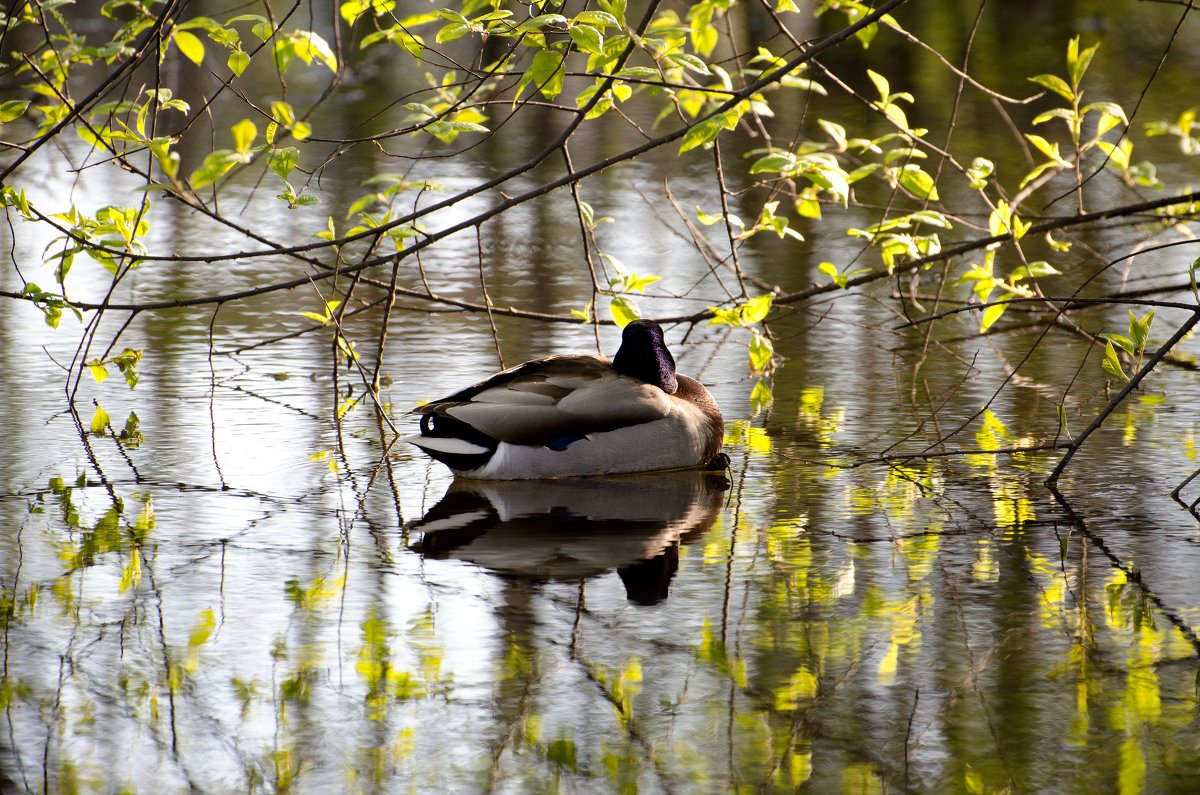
[413,355,671,446]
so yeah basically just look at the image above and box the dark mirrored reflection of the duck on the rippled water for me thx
[408,470,728,605]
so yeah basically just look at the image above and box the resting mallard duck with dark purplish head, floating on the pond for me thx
[403,319,728,480]
